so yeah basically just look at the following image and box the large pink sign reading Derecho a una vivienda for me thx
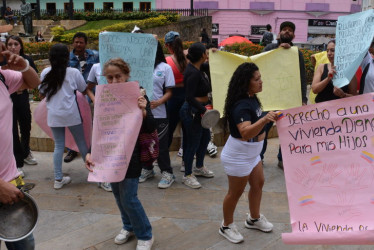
[277,94,374,245]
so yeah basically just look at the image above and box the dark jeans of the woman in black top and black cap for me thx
[179,102,210,176]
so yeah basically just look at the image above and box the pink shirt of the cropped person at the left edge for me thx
[0,70,23,181]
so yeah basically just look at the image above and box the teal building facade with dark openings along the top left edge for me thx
[6,0,156,13]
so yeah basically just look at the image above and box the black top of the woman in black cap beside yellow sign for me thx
[183,63,212,114]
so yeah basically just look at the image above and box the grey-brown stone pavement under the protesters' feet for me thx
[3,138,373,250]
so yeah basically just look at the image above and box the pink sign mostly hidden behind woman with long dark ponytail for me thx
[33,91,92,152]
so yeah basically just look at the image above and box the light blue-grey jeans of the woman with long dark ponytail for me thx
[51,123,87,180]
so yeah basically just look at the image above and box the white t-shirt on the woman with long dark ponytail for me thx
[40,67,87,127]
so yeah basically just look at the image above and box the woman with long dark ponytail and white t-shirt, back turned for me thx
[40,44,87,189]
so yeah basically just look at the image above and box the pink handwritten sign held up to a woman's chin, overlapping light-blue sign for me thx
[88,82,143,182]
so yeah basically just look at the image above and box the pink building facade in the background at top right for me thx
[156,0,362,43]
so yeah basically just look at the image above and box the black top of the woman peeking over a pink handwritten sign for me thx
[125,96,156,179]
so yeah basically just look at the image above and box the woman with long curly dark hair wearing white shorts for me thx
[219,63,277,243]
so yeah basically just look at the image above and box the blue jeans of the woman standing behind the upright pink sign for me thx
[111,178,152,240]
